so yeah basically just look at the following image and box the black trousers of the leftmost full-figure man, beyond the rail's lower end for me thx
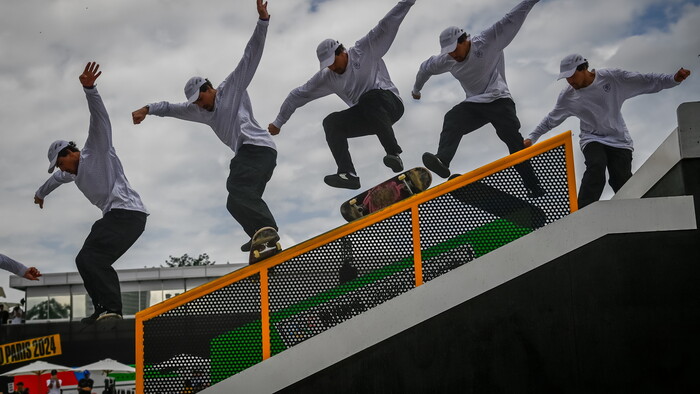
[75,209,147,312]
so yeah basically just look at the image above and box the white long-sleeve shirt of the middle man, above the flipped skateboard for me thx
[272,0,416,127]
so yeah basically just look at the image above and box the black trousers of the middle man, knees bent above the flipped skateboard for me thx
[323,89,404,174]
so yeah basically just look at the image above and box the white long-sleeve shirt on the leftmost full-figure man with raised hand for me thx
[36,87,148,215]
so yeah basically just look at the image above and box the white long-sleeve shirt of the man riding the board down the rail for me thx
[148,19,276,153]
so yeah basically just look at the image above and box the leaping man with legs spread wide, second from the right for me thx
[412,0,544,198]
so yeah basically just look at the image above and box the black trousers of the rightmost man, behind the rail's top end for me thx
[578,142,632,208]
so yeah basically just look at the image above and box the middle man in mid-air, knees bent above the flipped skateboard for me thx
[268,0,416,189]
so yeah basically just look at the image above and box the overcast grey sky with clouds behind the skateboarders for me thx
[0,0,700,301]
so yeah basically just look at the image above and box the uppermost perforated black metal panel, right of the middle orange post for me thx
[419,146,571,282]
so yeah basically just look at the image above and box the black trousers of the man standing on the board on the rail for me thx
[226,144,278,238]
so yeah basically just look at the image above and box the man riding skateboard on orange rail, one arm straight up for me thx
[132,0,279,251]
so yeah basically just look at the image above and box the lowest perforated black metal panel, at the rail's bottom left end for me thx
[144,274,262,393]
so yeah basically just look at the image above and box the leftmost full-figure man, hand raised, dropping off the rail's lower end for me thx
[34,62,148,324]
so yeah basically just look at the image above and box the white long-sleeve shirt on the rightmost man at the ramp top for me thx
[528,69,679,150]
